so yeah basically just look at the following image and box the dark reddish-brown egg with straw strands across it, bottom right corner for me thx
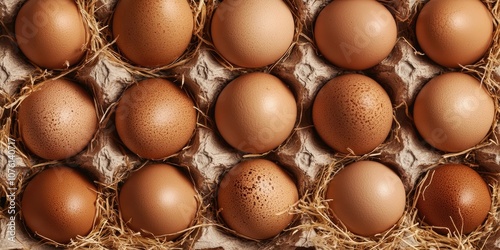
[416,164,491,234]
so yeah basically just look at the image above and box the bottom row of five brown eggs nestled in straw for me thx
[21,158,492,244]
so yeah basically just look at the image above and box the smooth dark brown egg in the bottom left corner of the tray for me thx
[21,166,97,244]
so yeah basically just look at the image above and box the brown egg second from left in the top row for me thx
[112,0,194,67]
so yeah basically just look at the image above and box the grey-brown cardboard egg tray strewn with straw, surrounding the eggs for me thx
[0,0,500,249]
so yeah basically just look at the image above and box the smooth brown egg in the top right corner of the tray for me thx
[416,0,493,68]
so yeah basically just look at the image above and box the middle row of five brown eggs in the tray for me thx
[18,69,495,160]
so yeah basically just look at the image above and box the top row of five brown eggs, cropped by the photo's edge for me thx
[15,0,493,70]
